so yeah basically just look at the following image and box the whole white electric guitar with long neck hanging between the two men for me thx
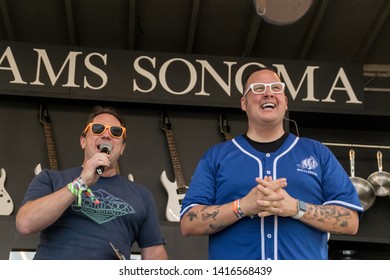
[160,113,188,222]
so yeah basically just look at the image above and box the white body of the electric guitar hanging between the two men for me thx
[160,170,187,222]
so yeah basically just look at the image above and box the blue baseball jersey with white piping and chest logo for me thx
[181,134,363,260]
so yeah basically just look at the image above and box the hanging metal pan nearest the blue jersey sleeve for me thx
[349,149,376,210]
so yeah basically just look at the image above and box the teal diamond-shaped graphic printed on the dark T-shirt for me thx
[72,190,135,224]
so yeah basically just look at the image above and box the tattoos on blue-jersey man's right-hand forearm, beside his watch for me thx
[306,204,351,233]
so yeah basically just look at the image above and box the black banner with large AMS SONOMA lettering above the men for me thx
[0,42,364,112]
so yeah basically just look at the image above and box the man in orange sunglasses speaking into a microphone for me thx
[16,106,167,259]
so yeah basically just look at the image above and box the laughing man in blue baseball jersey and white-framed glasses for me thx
[180,68,363,260]
